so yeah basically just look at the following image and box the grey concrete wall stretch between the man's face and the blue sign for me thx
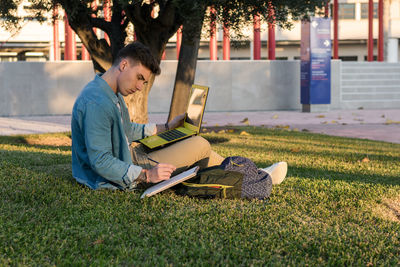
[149,60,301,112]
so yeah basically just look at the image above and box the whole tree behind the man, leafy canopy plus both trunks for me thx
[0,0,326,122]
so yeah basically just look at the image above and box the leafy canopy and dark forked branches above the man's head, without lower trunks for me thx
[0,0,326,65]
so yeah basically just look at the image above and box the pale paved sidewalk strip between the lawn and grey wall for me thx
[0,109,400,143]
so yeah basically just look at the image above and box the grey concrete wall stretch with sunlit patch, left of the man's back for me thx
[0,61,93,116]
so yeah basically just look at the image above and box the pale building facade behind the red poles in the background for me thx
[0,0,400,62]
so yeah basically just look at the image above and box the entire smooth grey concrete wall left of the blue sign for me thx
[0,61,301,116]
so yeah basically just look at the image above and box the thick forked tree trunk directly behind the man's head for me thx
[60,0,181,123]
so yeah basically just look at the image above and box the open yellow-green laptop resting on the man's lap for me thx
[139,84,208,149]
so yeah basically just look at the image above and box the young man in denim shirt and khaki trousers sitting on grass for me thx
[71,42,286,193]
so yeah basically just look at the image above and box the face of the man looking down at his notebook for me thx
[117,59,151,96]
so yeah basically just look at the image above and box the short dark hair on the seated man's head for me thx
[113,41,161,75]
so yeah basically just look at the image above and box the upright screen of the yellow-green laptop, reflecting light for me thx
[185,87,207,128]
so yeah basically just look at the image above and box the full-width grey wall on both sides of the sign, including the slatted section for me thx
[0,60,400,116]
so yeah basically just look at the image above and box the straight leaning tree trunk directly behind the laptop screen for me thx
[168,9,204,121]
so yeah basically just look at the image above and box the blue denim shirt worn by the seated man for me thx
[71,75,155,190]
